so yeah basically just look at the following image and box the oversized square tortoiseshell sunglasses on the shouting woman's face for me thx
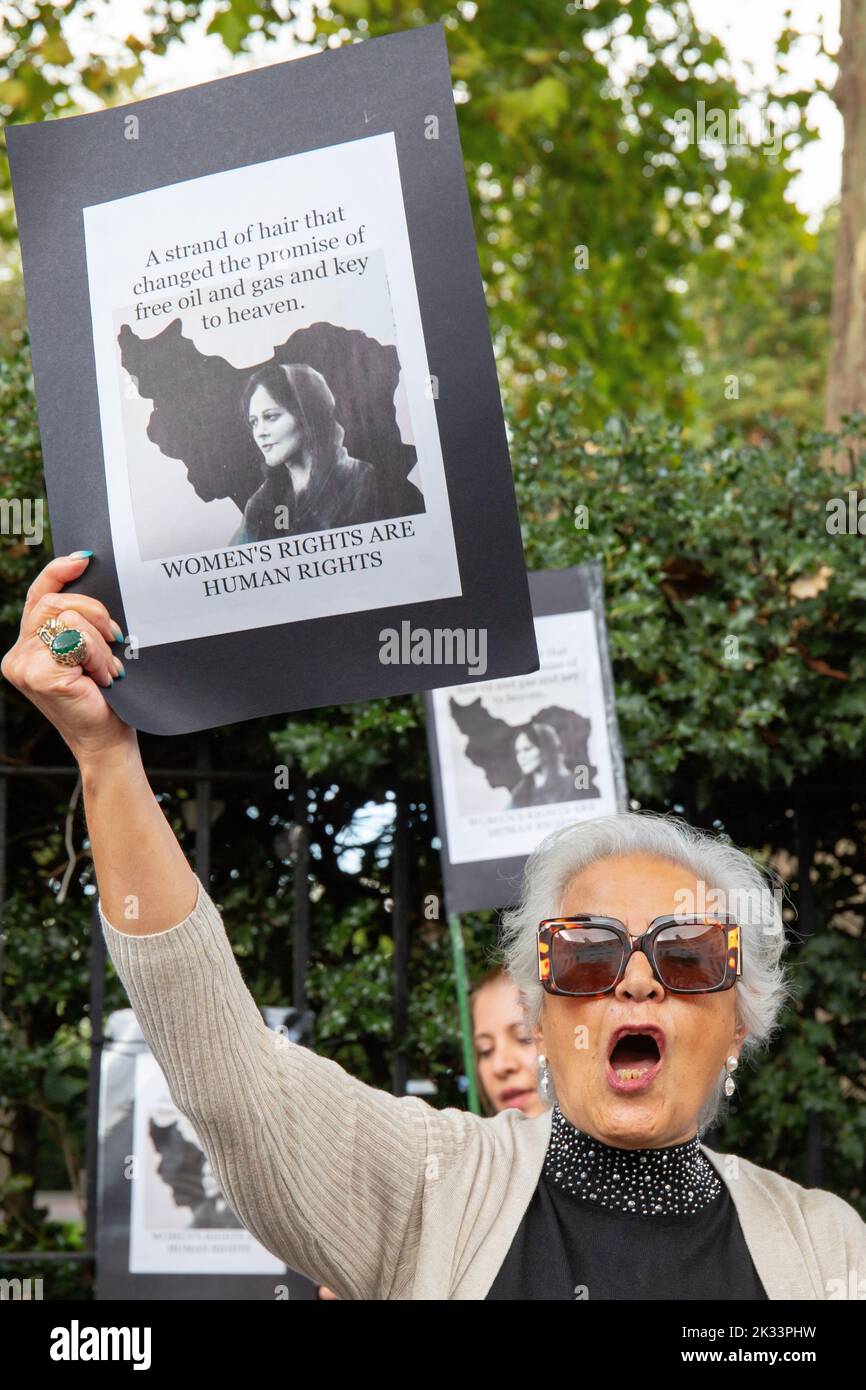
[538,913,742,997]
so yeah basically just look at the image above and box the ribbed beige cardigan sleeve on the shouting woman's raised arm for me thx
[100,861,453,1298]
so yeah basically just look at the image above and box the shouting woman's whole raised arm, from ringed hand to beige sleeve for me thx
[0,557,477,1298]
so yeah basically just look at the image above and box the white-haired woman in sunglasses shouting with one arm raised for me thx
[0,552,866,1300]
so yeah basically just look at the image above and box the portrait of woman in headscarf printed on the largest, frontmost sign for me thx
[229,363,420,545]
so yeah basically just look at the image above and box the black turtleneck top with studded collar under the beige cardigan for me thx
[487,1105,767,1302]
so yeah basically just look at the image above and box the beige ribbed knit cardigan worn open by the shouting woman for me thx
[99,876,866,1300]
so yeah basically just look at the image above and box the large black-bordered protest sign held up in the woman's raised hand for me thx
[7,25,538,734]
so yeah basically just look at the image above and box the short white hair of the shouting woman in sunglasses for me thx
[496,810,791,1133]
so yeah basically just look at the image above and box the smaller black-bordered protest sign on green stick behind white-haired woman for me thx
[425,563,628,913]
